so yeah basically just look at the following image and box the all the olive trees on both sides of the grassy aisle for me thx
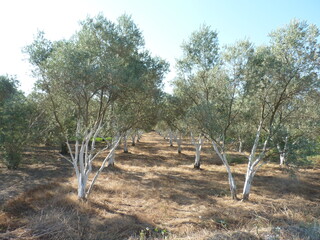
[0,15,320,200]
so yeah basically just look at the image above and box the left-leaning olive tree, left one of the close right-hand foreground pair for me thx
[174,26,239,198]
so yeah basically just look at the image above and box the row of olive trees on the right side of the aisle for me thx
[158,20,320,200]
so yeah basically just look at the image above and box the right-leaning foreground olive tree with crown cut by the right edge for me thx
[243,20,320,200]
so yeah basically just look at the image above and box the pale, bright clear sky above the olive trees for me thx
[0,0,320,94]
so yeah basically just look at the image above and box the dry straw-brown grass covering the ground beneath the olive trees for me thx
[0,133,320,240]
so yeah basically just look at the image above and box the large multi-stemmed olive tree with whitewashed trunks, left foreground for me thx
[26,15,168,199]
